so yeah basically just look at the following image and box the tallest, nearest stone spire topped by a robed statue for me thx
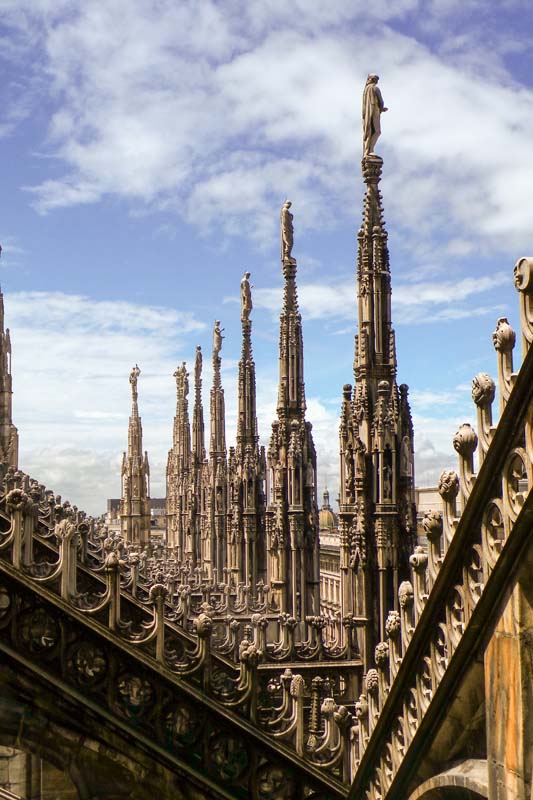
[339,81,415,666]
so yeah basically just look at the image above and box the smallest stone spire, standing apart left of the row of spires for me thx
[120,364,150,545]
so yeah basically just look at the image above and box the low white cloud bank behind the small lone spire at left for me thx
[6,292,206,512]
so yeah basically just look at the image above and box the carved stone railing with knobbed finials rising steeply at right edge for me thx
[350,259,533,800]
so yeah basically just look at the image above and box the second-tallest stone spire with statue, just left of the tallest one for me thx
[267,206,319,619]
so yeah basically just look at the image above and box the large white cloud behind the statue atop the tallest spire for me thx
[2,0,533,261]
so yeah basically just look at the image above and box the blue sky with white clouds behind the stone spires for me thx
[0,0,533,514]
